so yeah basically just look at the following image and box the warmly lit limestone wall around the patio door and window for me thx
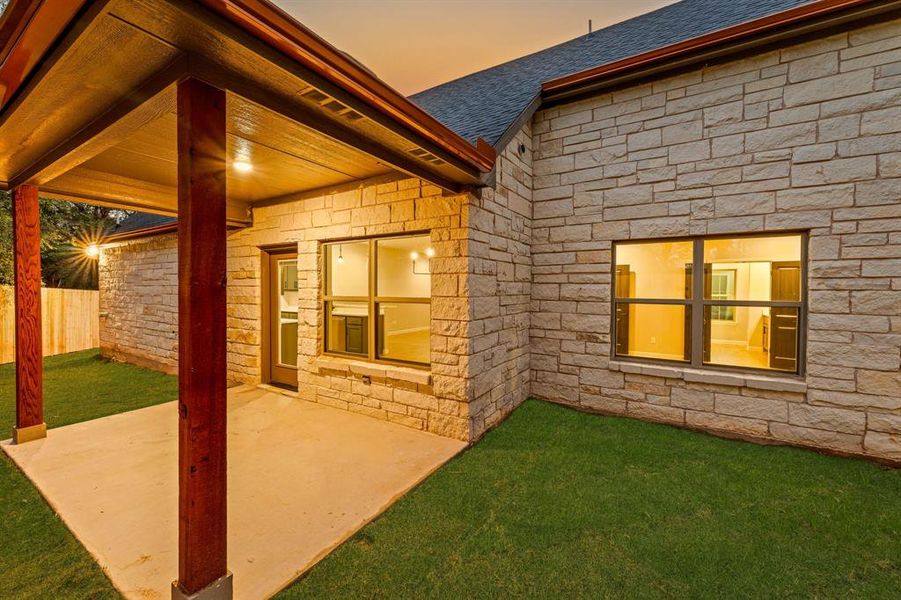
[228,177,471,440]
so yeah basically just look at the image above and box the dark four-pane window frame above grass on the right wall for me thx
[610,230,810,378]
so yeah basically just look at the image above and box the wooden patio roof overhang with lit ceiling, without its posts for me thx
[0,0,495,225]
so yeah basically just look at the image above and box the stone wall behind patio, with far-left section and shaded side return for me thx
[101,135,531,440]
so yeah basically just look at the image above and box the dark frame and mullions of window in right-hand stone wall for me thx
[610,229,810,376]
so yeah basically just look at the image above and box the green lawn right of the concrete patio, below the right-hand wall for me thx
[278,401,901,600]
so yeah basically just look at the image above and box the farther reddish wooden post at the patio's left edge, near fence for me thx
[12,185,47,444]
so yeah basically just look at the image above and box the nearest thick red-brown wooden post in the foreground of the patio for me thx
[172,79,232,600]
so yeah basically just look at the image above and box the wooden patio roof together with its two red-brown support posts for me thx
[0,0,495,599]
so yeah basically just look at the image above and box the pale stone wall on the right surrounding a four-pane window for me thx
[531,21,901,459]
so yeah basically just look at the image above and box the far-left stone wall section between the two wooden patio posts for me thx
[99,233,178,373]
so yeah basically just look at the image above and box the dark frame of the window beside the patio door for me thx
[319,230,432,370]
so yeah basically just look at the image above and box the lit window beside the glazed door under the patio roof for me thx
[323,235,434,365]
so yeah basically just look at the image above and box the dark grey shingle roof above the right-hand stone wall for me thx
[410,0,810,145]
